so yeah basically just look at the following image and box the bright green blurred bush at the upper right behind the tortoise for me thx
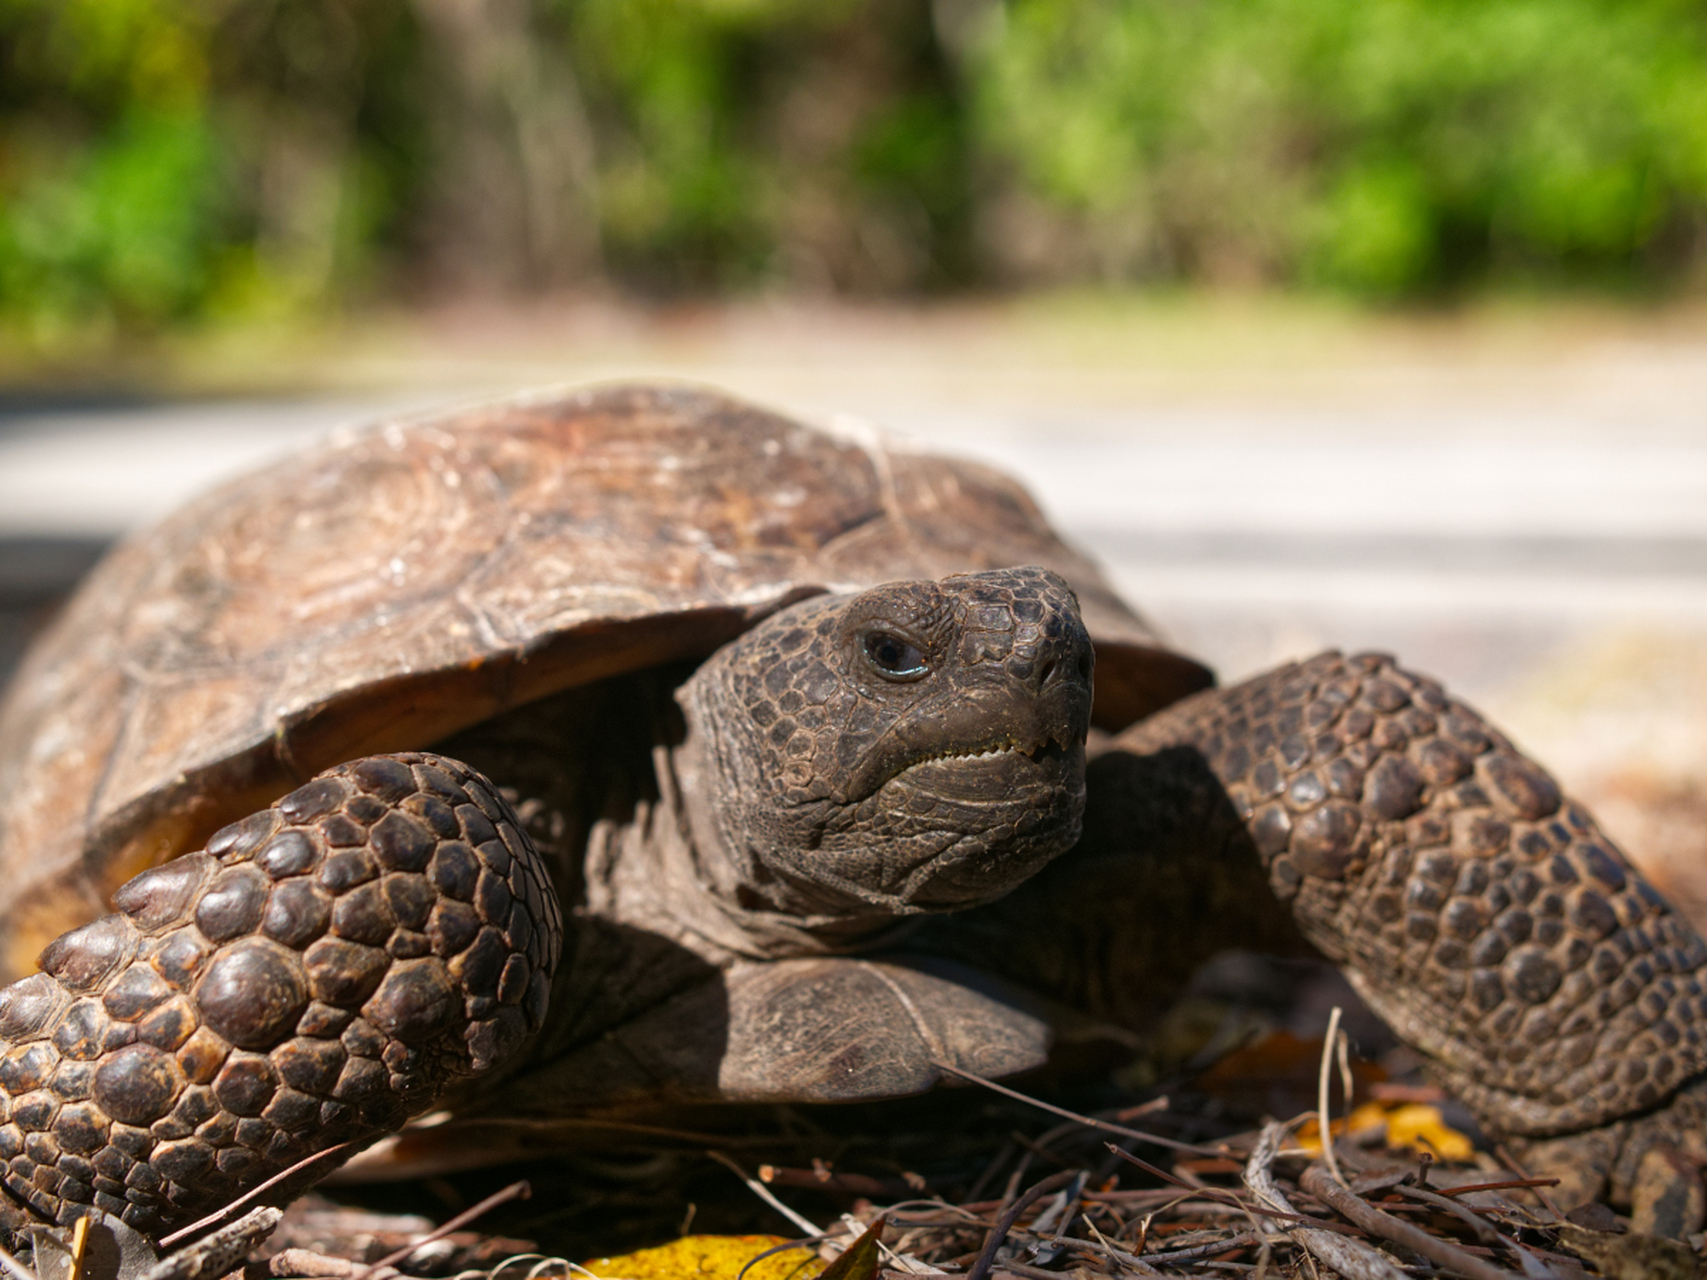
[980,0,1707,295]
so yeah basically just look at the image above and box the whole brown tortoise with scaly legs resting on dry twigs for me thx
[0,386,1707,1234]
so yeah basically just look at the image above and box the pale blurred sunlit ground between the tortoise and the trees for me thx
[0,300,1707,922]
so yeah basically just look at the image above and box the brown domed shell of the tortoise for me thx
[0,386,1210,980]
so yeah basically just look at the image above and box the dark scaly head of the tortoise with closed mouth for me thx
[678,568,1092,918]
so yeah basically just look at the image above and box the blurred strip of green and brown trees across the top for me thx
[0,0,1707,341]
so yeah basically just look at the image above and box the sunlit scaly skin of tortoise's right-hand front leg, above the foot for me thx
[1118,654,1707,1135]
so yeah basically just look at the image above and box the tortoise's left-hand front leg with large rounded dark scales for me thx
[0,753,563,1232]
